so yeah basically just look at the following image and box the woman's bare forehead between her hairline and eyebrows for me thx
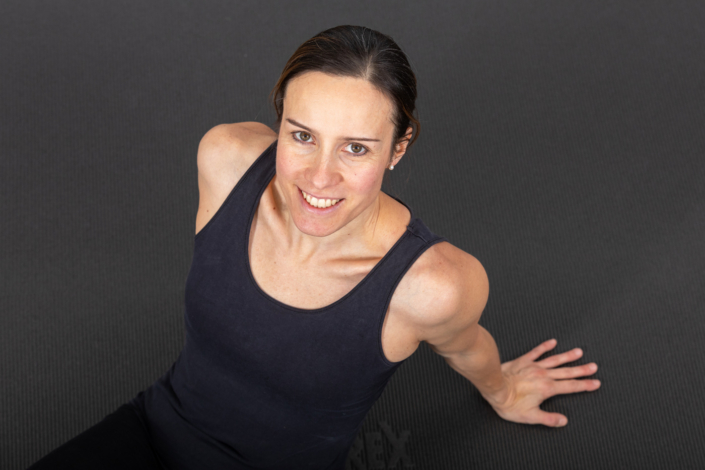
[283,72,394,139]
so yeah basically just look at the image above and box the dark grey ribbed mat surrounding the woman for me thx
[0,0,705,469]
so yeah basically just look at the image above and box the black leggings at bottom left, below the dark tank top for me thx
[28,403,165,470]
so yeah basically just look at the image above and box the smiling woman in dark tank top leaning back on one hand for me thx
[28,26,599,469]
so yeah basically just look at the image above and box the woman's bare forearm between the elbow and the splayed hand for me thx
[444,325,509,403]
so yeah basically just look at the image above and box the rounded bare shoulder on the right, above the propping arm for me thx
[399,241,489,349]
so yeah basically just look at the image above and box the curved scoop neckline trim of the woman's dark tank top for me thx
[244,170,416,314]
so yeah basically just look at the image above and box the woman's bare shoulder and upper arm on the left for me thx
[196,122,277,237]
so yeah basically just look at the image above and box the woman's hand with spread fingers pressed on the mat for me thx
[485,339,600,427]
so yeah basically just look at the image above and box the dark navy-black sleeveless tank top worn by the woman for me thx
[133,141,445,470]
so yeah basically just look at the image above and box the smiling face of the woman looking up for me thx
[276,72,406,237]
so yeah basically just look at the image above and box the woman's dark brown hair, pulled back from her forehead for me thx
[270,25,421,153]
